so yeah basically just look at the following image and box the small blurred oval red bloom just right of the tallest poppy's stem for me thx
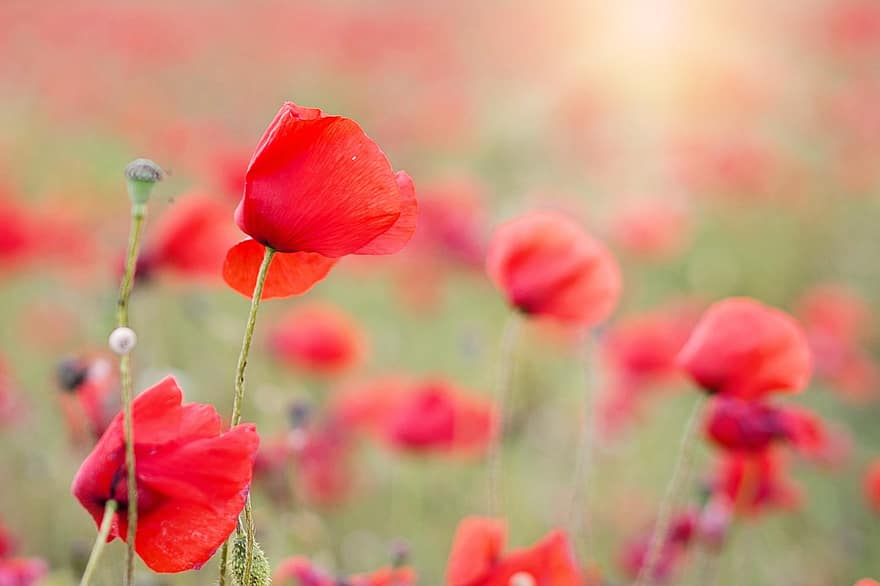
[269,303,366,375]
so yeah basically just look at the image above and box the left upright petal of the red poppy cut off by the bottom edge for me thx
[446,517,507,586]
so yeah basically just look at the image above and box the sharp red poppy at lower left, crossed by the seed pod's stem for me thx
[72,377,259,572]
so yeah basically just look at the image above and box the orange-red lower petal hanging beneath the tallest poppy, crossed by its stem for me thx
[223,238,336,299]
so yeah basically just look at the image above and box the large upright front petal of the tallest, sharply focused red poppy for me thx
[235,103,401,258]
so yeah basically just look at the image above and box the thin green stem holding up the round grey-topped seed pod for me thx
[116,204,145,586]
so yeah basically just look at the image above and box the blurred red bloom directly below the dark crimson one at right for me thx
[711,448,801,515]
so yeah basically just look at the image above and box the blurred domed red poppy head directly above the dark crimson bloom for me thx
[678,298,811,400]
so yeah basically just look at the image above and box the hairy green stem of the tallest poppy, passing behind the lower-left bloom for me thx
[220,246,275,586]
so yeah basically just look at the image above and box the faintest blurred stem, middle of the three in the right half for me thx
[564,331,601,551]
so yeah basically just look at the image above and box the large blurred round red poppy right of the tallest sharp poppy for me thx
[486,212,621,327]
